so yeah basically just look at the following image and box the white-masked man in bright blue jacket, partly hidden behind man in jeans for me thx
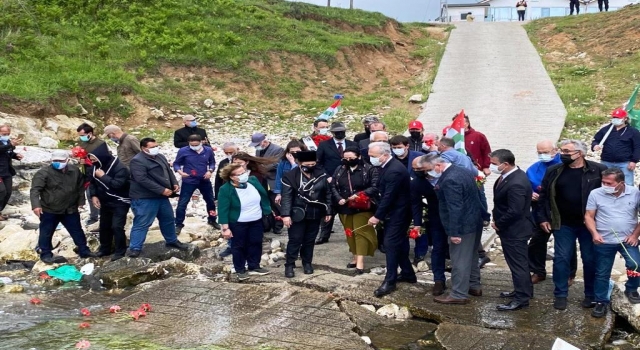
[527,140,578,284]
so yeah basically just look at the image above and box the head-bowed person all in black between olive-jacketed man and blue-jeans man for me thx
[89,148,131,261]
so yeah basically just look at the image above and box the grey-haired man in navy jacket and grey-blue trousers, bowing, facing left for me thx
[425,153,483,304]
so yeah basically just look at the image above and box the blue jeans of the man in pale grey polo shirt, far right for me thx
[594,243,640,303]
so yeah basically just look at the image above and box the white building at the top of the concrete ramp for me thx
[440,0,639,22]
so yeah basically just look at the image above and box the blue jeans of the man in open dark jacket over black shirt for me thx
[553,225,596,298]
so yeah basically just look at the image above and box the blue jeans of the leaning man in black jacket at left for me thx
[129,198,178,250]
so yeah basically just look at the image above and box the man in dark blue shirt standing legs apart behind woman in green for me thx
[173,135,220,234]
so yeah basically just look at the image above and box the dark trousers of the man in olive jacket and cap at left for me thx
[38,212,91,258]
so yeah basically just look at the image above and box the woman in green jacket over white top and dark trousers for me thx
[218,164,271,281]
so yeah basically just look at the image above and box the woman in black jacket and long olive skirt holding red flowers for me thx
[331,147,378,275]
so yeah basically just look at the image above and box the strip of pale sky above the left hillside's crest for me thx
[290,0,440,22]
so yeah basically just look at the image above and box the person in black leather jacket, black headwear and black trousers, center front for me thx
[280,151,331,278]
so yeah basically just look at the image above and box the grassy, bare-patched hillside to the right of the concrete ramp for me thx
[527,5,640,138]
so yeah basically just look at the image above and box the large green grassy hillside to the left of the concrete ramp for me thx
[0,0,447,134]
